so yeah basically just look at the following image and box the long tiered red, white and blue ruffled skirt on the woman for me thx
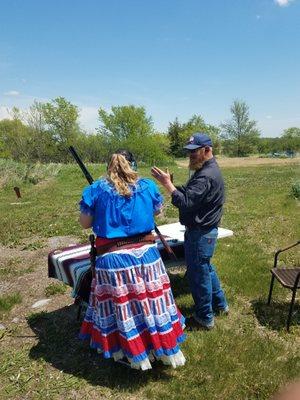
[80,244,185,370]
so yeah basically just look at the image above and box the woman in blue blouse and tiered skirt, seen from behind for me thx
[80,150,185,370]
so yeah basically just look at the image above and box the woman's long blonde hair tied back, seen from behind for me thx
[107,154,138,197]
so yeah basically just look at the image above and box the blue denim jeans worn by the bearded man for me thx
[184,228,227,324]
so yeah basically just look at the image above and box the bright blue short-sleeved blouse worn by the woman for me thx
[79,178,163,239]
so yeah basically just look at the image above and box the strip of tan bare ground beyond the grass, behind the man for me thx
[177,156,300,168]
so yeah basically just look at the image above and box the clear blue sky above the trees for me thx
[0,0,300,136]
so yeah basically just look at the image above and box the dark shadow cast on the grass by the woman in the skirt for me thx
[28,305,175,391]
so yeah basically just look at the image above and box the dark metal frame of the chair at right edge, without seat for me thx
[268,240,300,332]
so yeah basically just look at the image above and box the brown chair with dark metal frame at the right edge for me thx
[268,240,300,332]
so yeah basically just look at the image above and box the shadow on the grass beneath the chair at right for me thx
[251,299,300,331]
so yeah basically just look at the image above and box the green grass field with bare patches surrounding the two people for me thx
[0,160,300,400]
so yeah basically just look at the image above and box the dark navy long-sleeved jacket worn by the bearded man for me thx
[172,158,225,231]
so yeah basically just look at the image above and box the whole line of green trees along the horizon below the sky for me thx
[0,97,300,164]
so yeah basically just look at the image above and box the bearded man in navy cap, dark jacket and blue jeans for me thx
[151,132,229,329]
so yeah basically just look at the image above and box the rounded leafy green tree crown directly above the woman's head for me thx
[98,105,153,141]
